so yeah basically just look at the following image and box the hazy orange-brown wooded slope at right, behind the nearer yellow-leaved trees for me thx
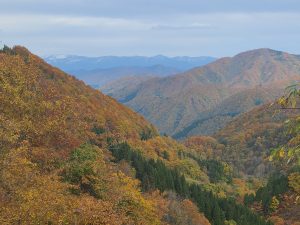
[184,101,299,177]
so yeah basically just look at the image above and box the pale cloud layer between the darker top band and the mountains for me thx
[0,12,300,56]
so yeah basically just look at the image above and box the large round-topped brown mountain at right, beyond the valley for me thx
[103,48,300,135]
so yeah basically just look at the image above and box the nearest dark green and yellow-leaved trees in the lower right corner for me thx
[244,110,300,224]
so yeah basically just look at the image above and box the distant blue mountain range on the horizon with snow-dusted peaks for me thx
[45,55,216,88]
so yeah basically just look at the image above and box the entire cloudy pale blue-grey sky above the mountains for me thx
[0,0,300,57]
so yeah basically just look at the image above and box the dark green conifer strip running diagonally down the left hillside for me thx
[110,143,271,225]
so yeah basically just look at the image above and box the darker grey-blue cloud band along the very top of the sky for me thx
[0,0,300,19]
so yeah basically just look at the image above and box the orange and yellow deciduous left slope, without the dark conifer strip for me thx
[0,47,170,224]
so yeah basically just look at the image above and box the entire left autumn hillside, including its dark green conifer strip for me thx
[0,47,276,225]
